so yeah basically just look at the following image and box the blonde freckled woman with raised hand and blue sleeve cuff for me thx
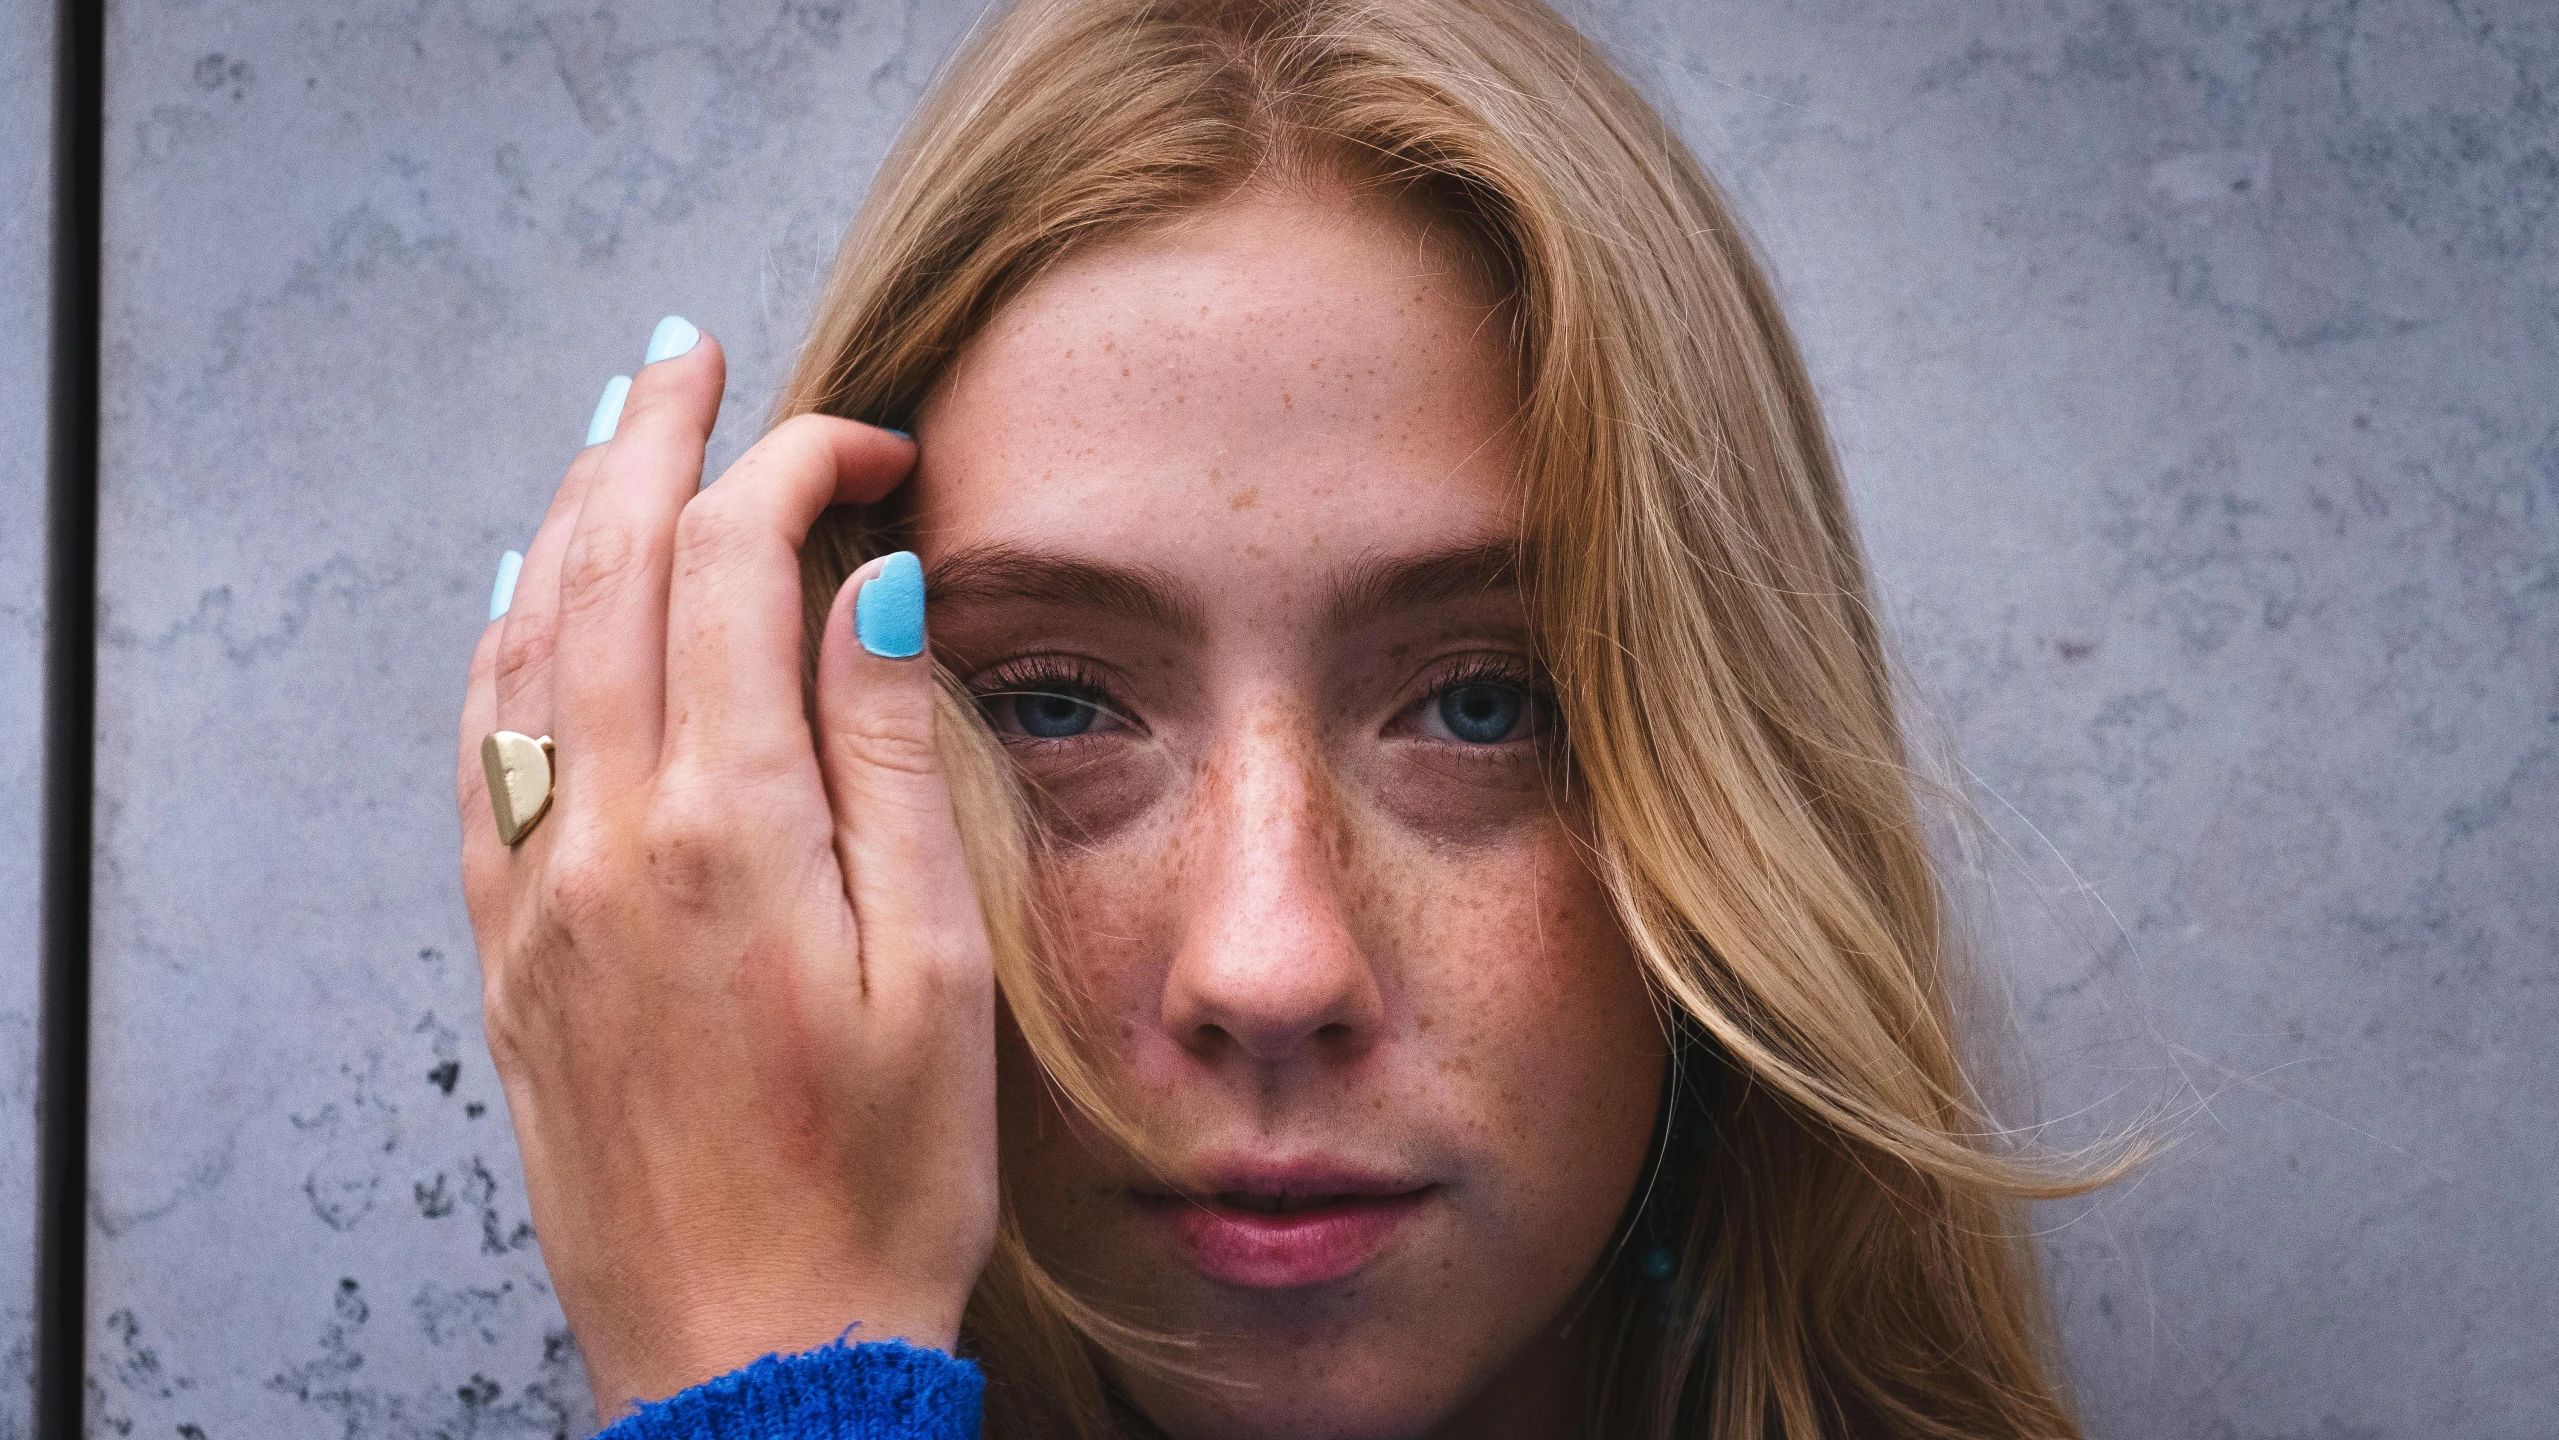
[461,0,2086,1440]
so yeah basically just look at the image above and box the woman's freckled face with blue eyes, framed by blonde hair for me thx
[911,194,1663,1437]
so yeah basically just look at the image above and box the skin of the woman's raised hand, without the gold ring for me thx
[456,335,995,1417]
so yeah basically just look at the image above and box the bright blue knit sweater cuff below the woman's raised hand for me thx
[596,1340,985,1440]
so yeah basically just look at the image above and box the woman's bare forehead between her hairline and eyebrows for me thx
[911,194,1517,583]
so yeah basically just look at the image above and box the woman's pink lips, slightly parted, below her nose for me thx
[1136,1164,1438,1289]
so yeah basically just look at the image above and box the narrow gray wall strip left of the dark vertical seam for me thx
[0,0,54,1440]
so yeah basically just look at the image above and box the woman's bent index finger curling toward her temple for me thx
[665,414,916,783]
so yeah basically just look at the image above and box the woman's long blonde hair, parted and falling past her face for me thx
[778,0,2114,1440]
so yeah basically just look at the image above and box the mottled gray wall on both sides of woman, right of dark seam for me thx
[60,0,2559,1440]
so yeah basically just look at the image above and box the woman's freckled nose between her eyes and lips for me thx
[1164,721,1384,1067]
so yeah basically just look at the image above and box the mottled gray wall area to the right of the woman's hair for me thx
[1612,0,2559,1440]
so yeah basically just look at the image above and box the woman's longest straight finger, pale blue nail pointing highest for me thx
[553,317,729,793]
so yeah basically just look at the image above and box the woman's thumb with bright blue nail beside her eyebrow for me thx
[816,550,993,1002]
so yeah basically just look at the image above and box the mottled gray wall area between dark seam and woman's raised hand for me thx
[90,0,965,1440]
